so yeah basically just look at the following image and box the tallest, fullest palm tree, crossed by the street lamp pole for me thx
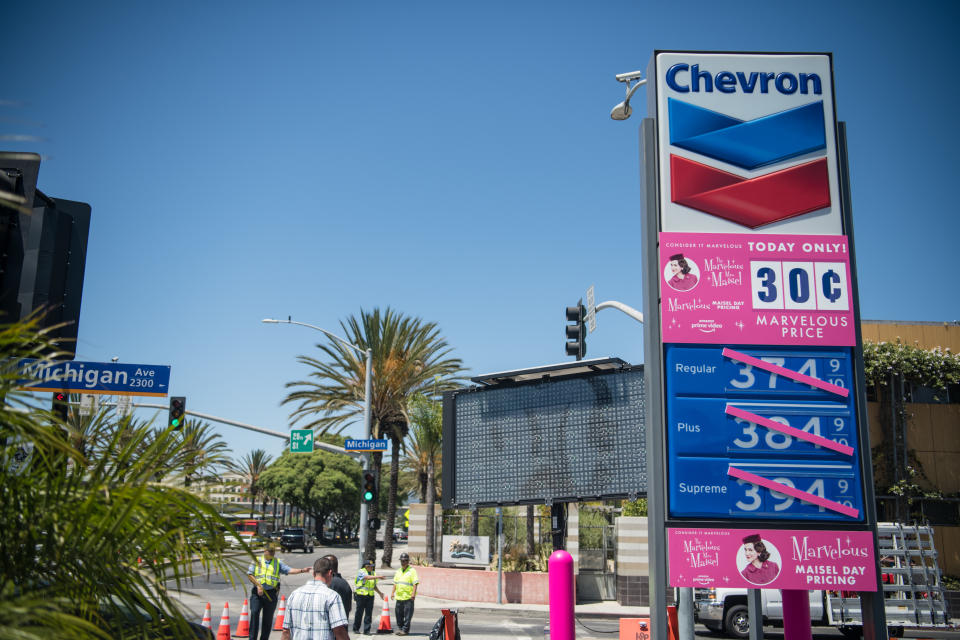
[283,307,462,567]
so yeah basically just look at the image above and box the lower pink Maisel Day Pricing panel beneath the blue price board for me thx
[668,529,877,591]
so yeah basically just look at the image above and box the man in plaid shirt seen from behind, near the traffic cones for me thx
[280,557,350,640]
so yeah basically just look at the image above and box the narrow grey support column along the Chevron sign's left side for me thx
[640,118,668,640]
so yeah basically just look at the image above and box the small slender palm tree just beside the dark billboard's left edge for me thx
[407,394,443,562]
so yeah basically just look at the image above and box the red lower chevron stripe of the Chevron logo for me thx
[670,155,830,229]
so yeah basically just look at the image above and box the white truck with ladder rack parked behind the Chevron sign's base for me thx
[694,523,952,638]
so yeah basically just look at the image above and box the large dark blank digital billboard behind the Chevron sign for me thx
[443,366,647,508]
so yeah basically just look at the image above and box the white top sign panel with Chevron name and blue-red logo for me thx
[649,52,842,234]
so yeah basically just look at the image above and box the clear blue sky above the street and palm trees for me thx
[0,0,960,457]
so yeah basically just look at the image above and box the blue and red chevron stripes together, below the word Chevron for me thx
[668,98,830,229]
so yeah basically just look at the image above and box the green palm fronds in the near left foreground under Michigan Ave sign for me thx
[0,322,238,640]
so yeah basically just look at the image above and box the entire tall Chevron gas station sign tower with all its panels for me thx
[641,51,886,640]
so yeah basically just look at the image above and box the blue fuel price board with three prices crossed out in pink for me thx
[666,345,864,522]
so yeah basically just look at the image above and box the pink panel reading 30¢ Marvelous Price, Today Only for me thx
[660,232,856,347]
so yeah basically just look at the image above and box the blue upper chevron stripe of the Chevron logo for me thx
[668,98,827,169]
